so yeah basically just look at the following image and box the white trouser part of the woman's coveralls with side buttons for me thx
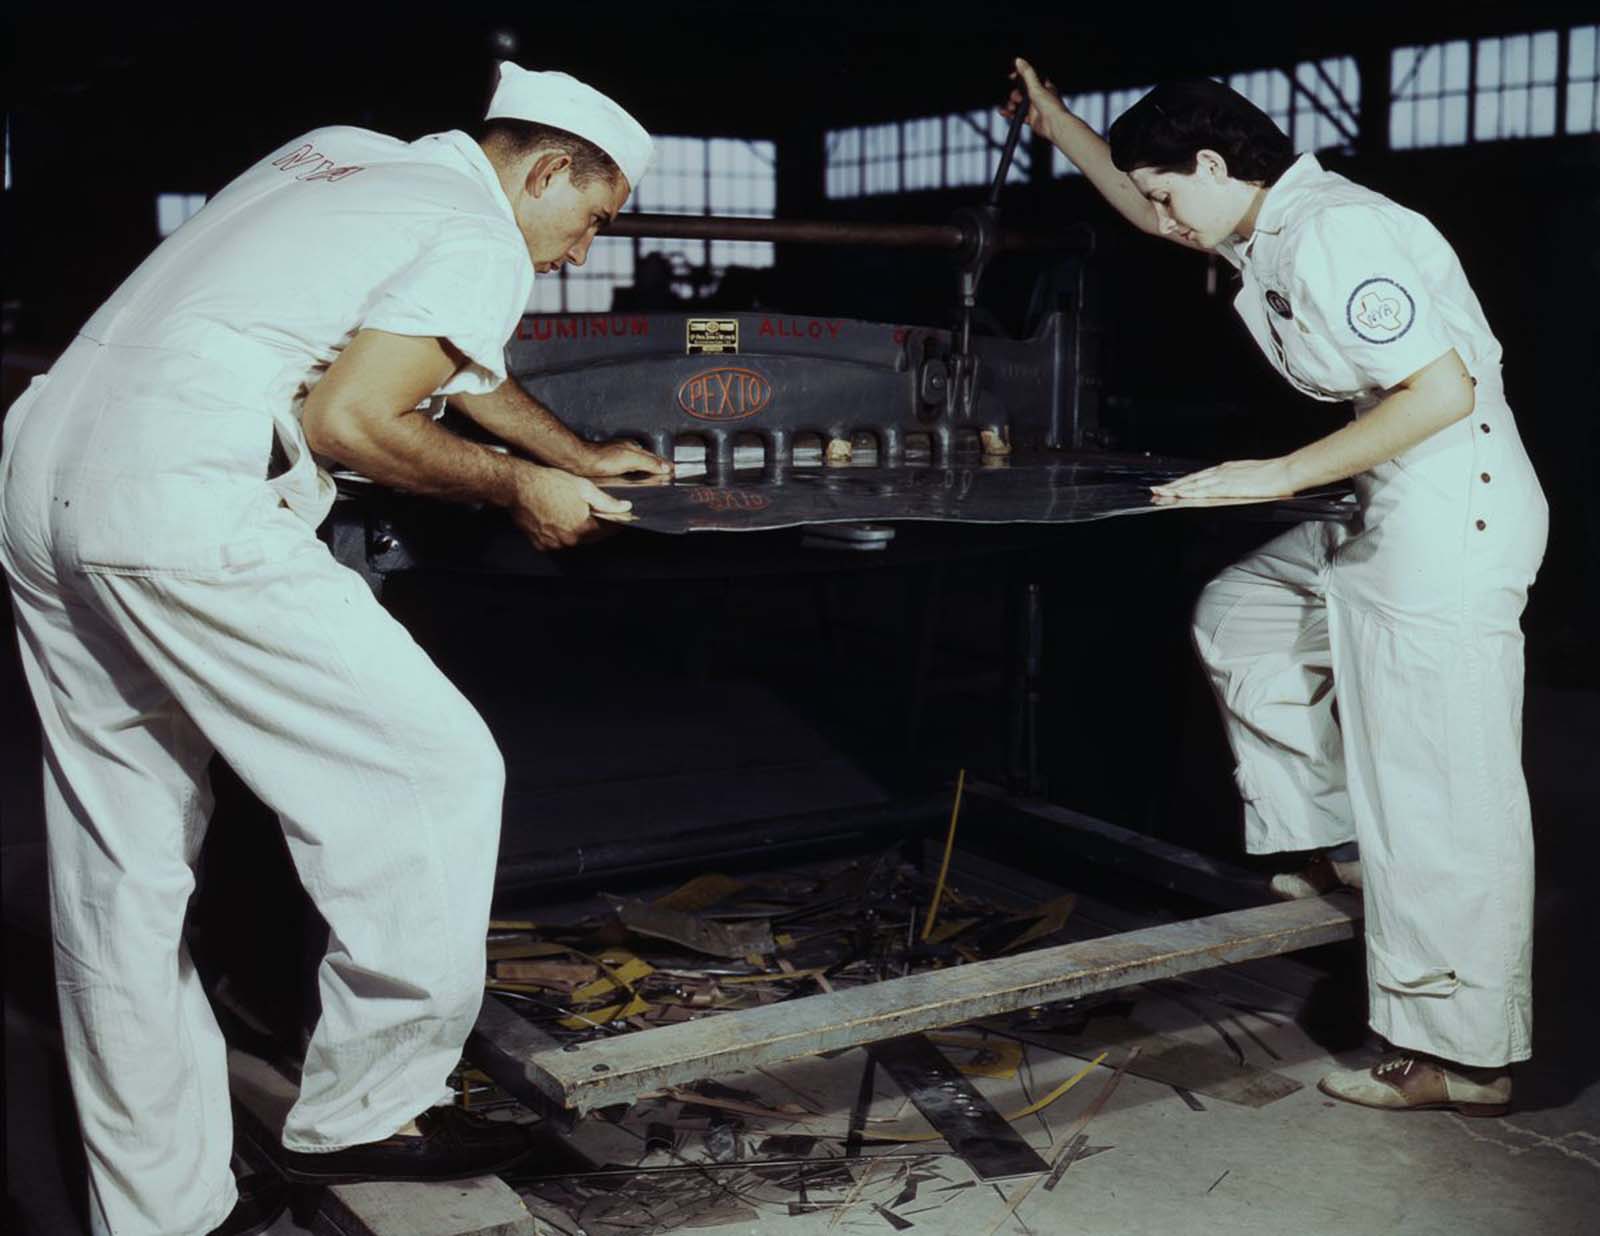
[1194,386,1547,1066]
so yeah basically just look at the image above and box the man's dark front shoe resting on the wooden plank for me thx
[272,1108,533,1185]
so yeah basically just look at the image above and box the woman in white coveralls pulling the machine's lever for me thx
[1011,61,1547,1116]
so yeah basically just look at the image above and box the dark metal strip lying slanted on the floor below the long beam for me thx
[867,1034,1050,1180]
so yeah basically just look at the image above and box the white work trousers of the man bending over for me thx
[0,339,504,1236]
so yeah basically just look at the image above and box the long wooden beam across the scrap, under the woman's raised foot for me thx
[492,895,1362,1113]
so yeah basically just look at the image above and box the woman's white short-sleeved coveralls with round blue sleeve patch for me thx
[1194,155,1549,1066]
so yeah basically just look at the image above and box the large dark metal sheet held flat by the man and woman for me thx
[606,456,1354,533]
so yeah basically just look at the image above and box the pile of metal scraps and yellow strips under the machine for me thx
[459,847,1299,1236]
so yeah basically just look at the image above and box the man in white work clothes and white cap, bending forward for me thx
[0,64,670,1236]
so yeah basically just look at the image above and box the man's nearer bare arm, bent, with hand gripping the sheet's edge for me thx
[301,330,630,549]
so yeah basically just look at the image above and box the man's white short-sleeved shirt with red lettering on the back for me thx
[83,128,533,419]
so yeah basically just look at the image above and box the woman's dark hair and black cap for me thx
[1109,78,1294,184]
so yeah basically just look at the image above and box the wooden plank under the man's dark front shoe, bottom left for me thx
[227,1049,541,1236]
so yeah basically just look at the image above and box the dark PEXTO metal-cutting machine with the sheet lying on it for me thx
[333,104,1344,586]
